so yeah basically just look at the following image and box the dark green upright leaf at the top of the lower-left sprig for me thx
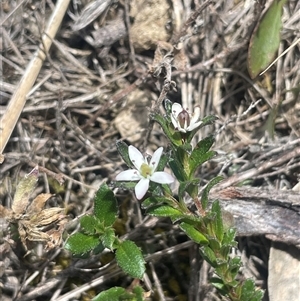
[94,184,118,227]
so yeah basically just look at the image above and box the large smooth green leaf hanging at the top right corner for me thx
[248,0,286,78]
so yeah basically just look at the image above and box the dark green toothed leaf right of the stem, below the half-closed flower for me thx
[189,136,215,177]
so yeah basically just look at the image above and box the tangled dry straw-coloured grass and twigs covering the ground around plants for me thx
[0,0,300,301]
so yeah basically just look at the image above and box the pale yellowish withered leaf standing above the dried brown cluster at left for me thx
[11,167,39,215]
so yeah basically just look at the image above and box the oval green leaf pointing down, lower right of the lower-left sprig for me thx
[116,240,146,279]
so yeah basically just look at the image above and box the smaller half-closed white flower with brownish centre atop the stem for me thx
[171,102,202,133]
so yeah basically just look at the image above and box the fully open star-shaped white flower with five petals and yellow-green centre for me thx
[116,145,174,200]
